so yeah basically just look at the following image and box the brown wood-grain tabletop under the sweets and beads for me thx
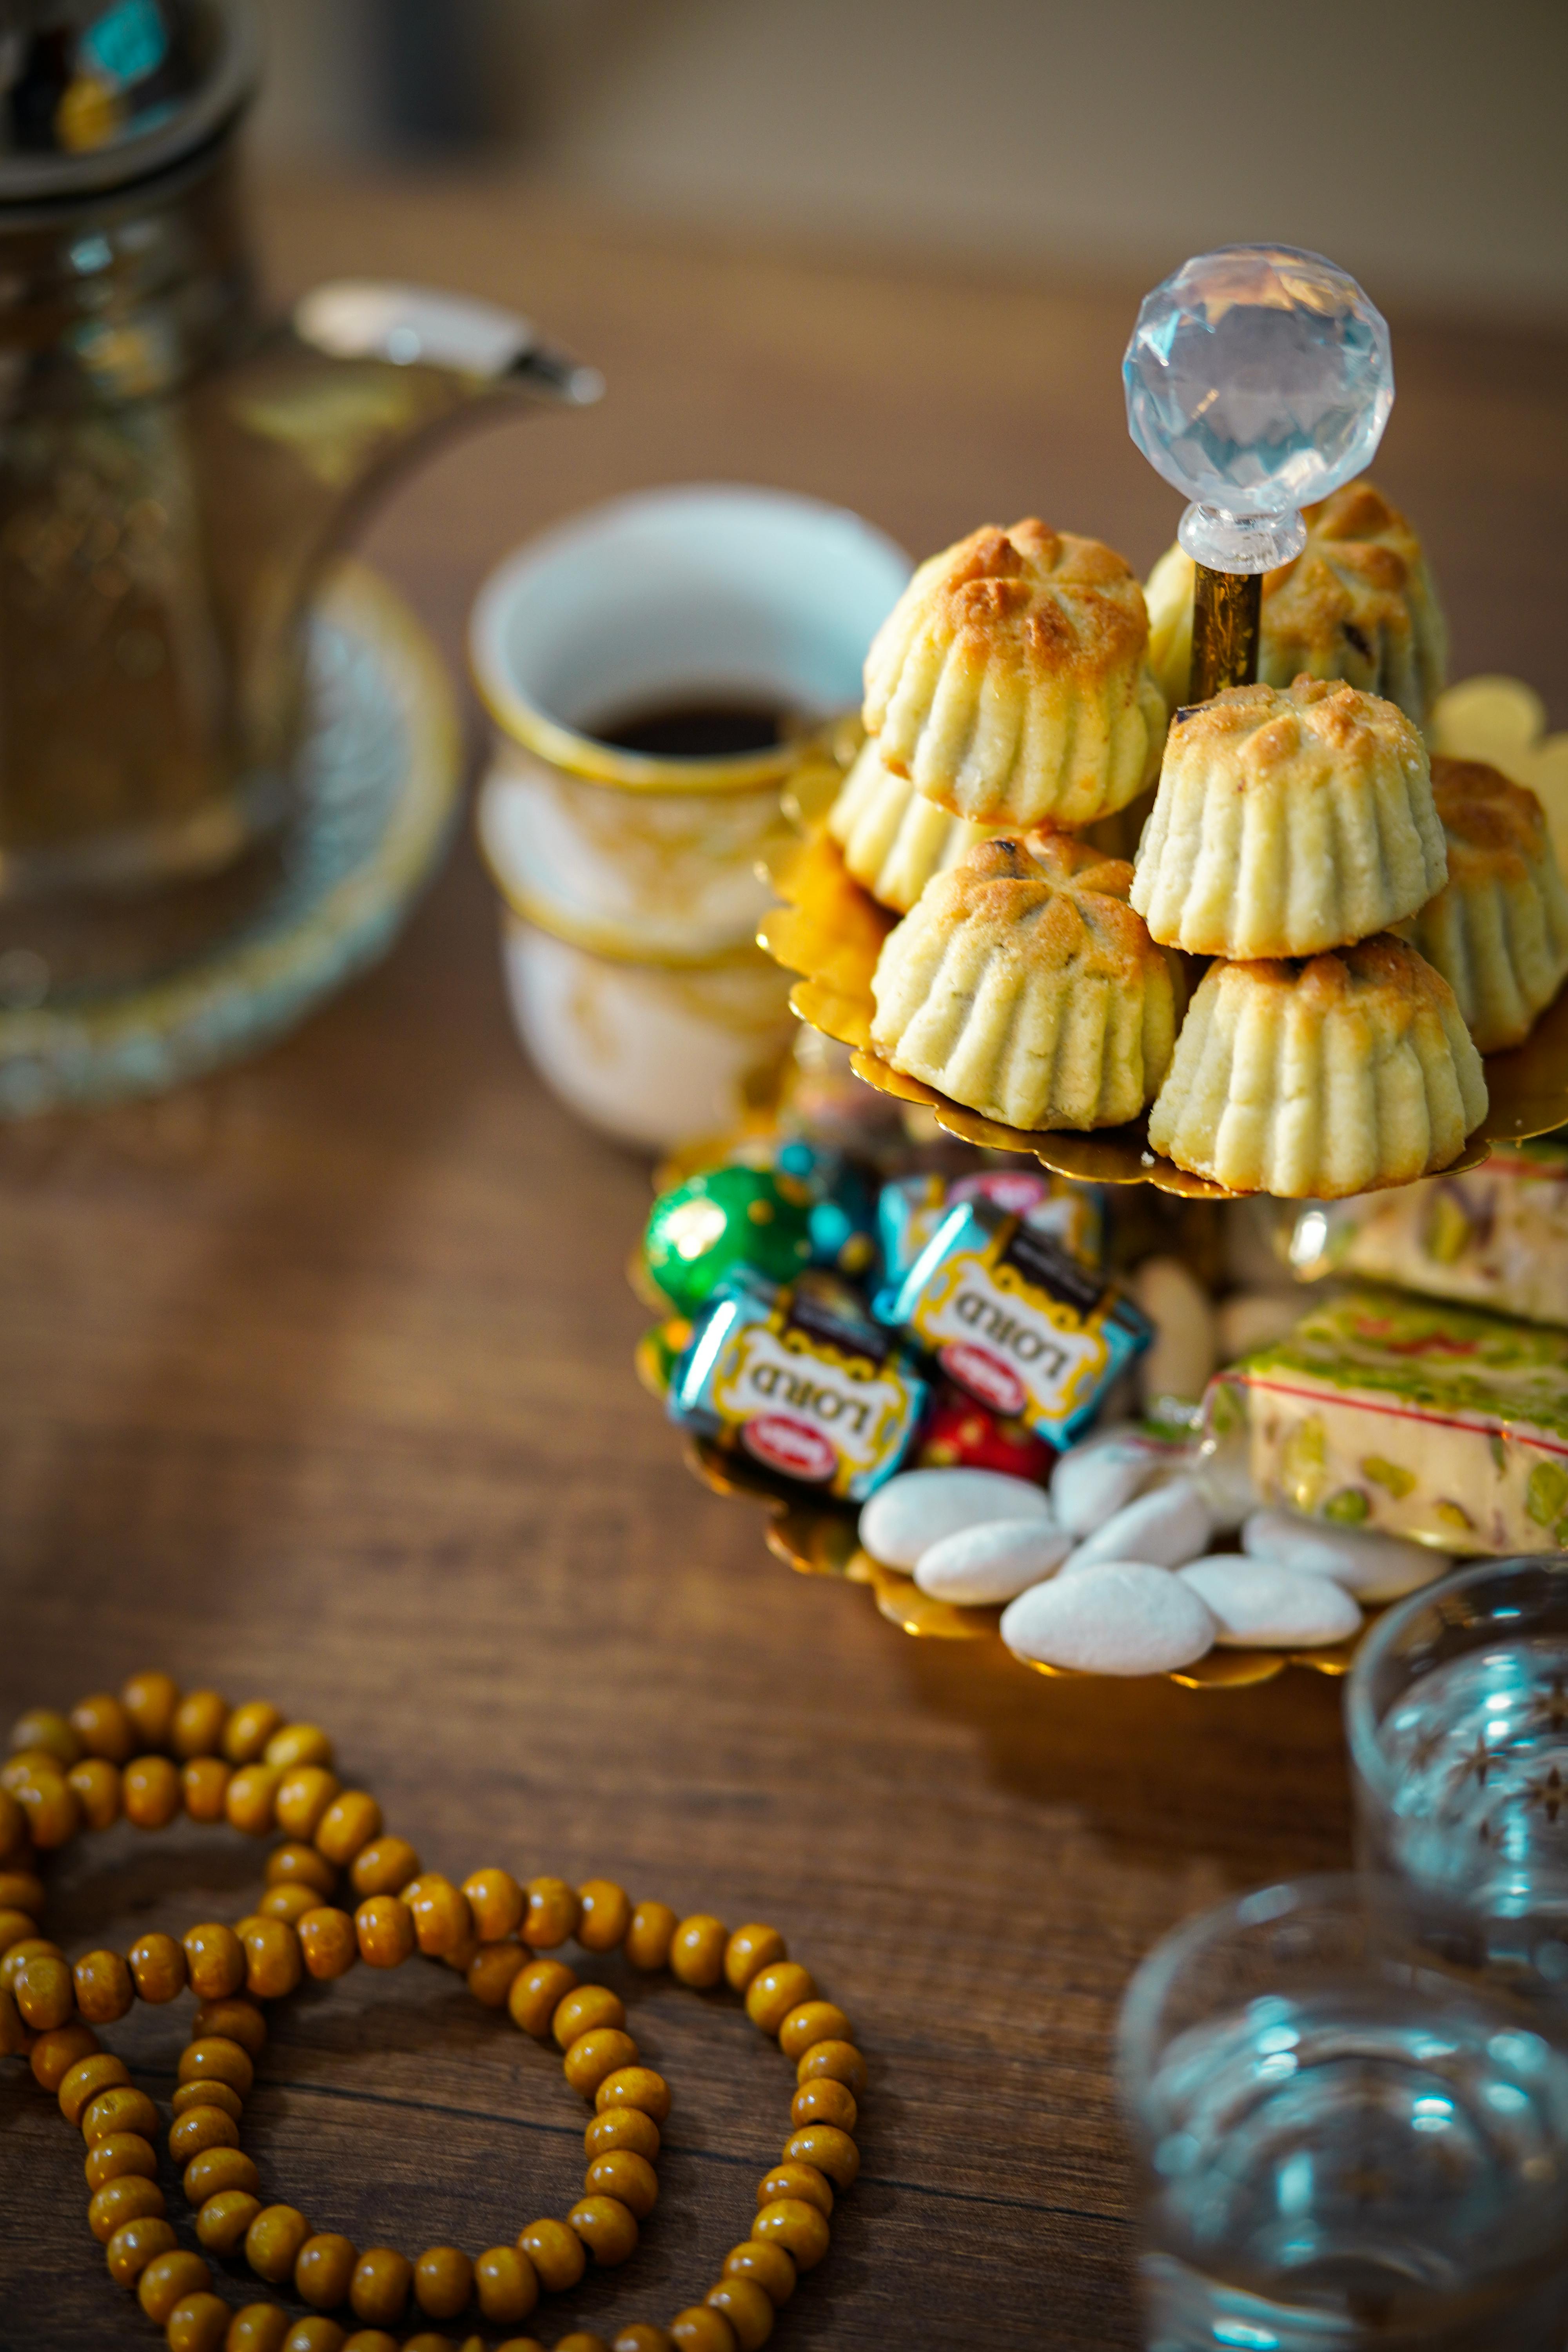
[0,183,1568,2352]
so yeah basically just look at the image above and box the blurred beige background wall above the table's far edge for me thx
[256,0,1568,322]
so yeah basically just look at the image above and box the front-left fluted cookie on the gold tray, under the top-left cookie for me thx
[872,833,1178,1127]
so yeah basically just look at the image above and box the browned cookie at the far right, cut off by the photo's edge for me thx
[1399,757,1568,1054]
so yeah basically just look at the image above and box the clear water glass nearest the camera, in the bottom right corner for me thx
[1119,1877,1568,2352]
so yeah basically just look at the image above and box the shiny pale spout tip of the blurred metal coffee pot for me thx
[294,278,604,407]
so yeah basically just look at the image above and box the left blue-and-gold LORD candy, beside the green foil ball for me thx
[670,1268,926,1503]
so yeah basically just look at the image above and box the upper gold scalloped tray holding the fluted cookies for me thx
[757,680,1568,1200]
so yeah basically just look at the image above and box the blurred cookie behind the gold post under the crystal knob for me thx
[1147,482,1448,727]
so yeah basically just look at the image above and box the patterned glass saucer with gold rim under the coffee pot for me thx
[0,562,463,1117]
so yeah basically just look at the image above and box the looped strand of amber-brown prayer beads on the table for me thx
[0,1672,865,2352]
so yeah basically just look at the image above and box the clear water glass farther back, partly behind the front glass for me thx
[1345,1555,1568,1990]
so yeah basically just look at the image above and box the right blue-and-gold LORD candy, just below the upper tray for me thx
[889,1200,1154,1446]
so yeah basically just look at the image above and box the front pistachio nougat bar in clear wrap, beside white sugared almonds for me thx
[1208,1287,1568,1552]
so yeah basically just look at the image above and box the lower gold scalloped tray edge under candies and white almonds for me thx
[632,1327,1359,1691]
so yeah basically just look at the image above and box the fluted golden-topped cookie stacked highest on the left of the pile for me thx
[865,520,1166,828]
